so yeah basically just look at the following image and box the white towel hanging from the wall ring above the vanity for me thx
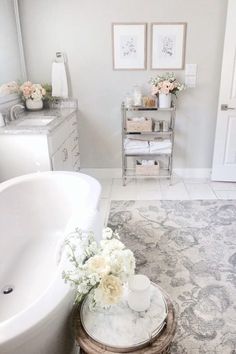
[52,62,68,98]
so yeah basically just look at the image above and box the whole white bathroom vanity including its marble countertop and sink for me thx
[0,108,80,182]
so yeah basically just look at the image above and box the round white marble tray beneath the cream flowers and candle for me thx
[80,284,167,349]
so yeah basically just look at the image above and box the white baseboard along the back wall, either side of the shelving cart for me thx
[81,168,211,178]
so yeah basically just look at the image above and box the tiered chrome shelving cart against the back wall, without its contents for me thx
[122,102,176,186]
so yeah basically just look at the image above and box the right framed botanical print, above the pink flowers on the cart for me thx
[151,22,187,70]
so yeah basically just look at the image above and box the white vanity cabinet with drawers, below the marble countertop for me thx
[0,111,80,182]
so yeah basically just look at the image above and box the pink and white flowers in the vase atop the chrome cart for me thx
[149,72,186,96]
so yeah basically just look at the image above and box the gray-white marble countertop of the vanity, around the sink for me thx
[0,108,77,135]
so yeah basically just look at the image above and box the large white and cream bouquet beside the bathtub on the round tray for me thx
[62,228,135,309]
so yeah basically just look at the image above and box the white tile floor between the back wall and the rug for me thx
[98,178,236,225]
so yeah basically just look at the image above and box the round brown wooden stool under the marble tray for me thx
[73,288,177,354]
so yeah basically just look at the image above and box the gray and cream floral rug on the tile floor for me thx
[108,200,236,354]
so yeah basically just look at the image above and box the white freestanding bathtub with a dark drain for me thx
[0,172,101,354]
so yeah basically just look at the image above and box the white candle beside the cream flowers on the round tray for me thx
[128,274,151,311]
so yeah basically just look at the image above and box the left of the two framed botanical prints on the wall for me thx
[112,23,147,70]
